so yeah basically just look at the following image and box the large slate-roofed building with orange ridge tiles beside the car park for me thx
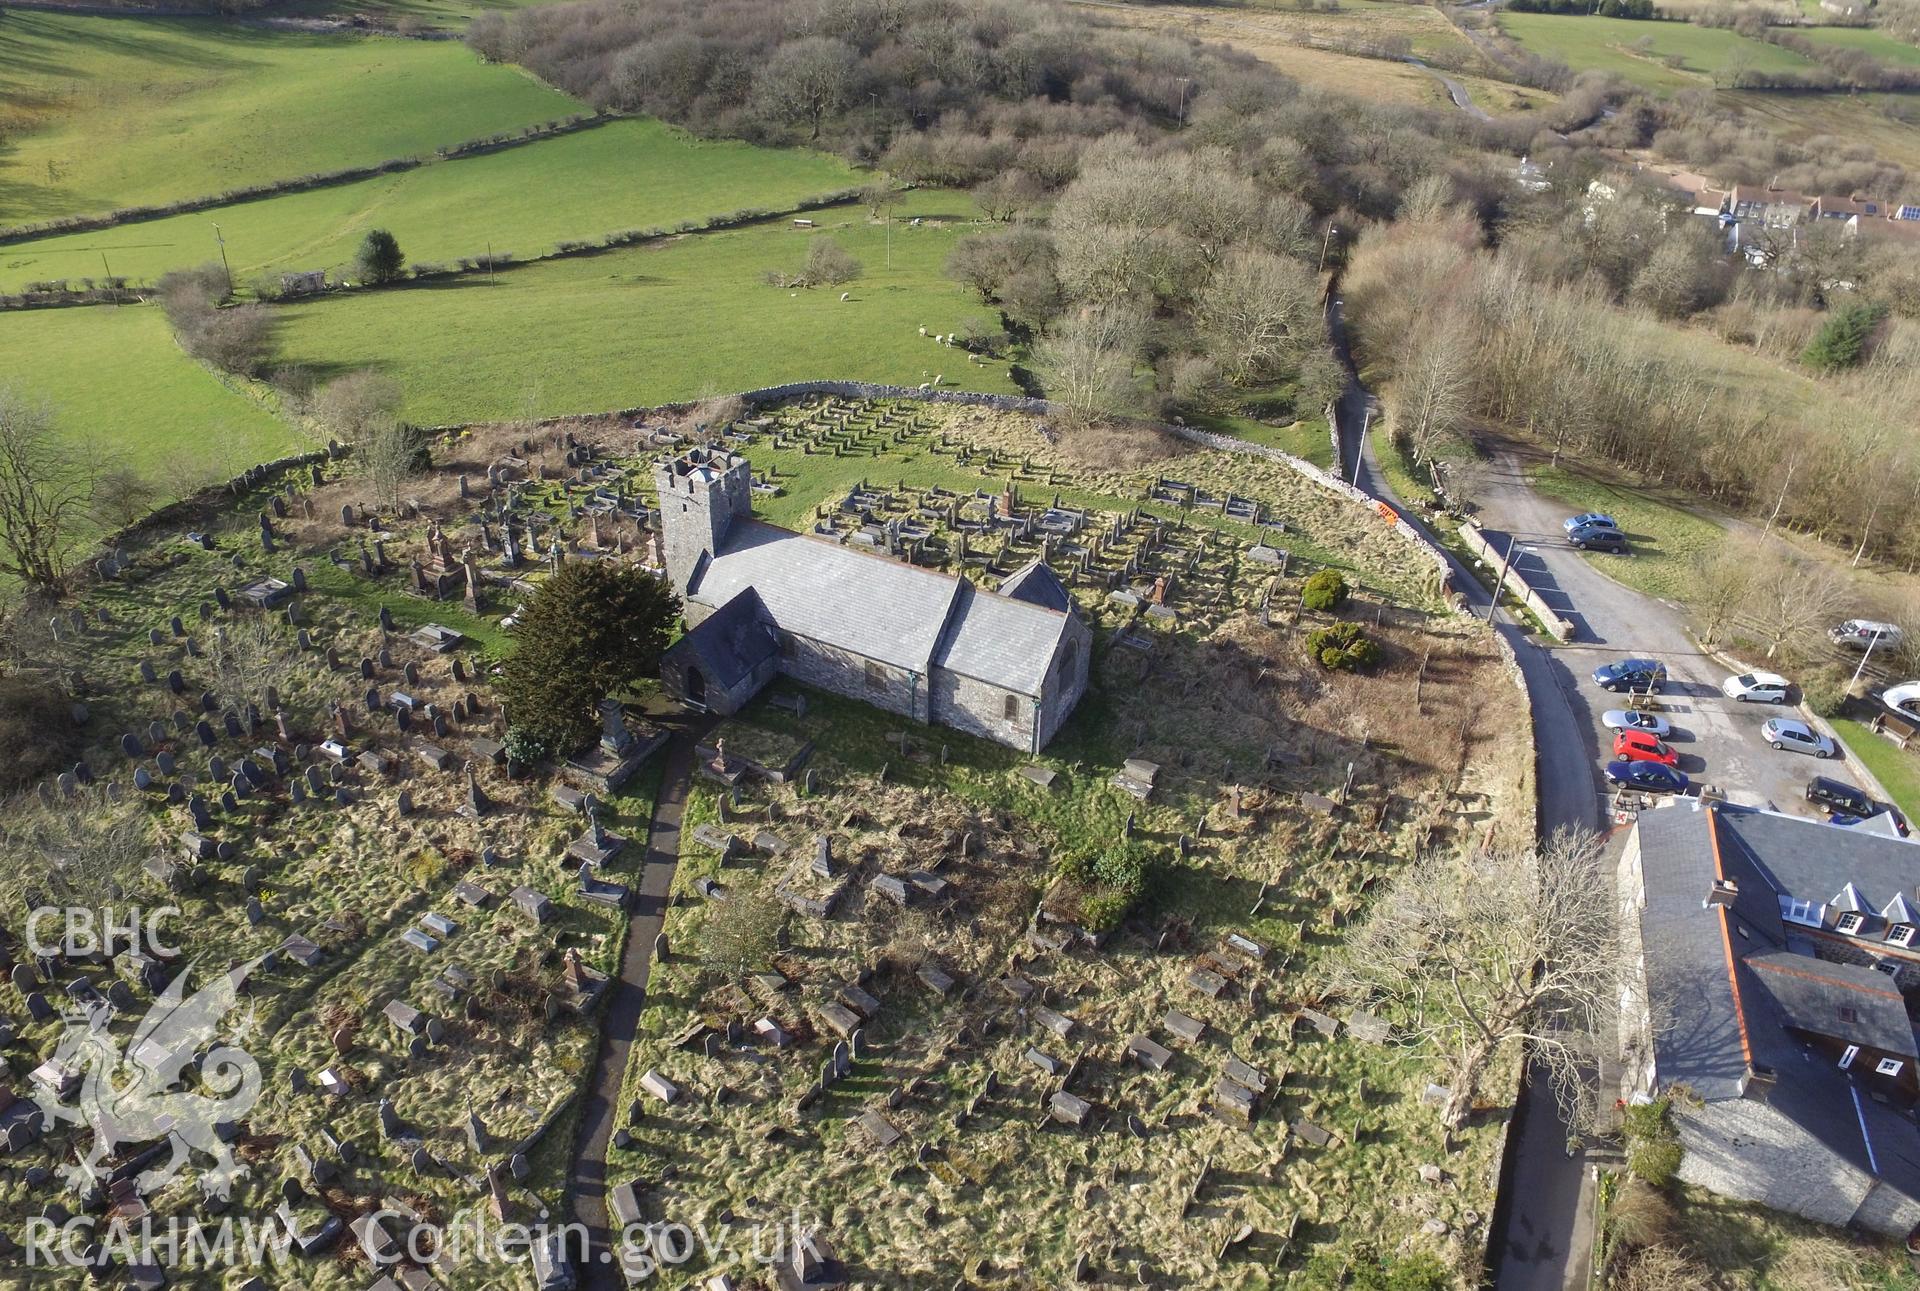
[1619,801,1920,1237]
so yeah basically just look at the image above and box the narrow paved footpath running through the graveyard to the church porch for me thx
[568,719,710,1291]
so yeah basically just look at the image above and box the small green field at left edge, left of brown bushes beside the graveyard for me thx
[0,305,301,498]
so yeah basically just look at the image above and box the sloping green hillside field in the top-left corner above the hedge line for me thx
[0,10,580,225]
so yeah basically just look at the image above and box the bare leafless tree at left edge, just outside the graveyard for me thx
[0,386,96,592]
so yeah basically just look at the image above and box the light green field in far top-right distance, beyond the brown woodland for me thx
[1500,13,1812,94]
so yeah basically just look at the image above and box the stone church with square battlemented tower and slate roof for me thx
[655,448,1092,751]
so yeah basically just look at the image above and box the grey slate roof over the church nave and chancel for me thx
[687,521,1068,695]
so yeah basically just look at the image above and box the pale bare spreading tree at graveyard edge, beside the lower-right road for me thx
[1334,834,1624,1130]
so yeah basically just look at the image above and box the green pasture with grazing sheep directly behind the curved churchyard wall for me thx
[280,192,1012,425]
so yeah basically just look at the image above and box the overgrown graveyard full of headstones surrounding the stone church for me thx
[0,396,1530,1287]
